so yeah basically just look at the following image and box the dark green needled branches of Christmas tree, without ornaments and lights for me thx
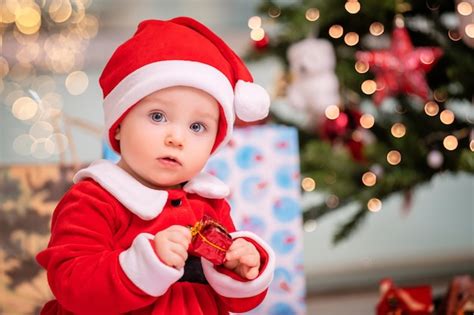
[247,0,474,243]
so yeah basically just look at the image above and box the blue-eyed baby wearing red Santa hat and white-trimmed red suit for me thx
[37,17,275,315]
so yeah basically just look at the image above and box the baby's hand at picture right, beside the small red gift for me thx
[224,238,260,280]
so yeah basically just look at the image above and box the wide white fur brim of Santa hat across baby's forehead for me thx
[104,60,235,153]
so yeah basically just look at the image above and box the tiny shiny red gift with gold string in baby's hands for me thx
[189,217,232,265]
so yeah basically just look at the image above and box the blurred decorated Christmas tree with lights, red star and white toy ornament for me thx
[247,0,474,243]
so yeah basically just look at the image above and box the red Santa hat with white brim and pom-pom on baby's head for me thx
[99,17,270,153]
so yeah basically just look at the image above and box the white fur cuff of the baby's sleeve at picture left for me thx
[119,233,184,296]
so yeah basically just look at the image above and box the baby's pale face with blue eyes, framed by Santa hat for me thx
[116,86,219,189]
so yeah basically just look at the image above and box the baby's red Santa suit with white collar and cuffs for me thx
[37,160,275,315]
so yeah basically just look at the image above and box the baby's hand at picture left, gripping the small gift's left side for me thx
[154,225,191,269]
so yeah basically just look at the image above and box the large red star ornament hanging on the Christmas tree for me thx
[356,27,443,105]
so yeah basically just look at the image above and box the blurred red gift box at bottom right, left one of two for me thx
[377,279,434,315]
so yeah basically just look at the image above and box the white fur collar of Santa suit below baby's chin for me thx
[73,160,229,220]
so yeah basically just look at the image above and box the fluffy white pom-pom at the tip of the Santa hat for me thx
[234,80,270,121]
